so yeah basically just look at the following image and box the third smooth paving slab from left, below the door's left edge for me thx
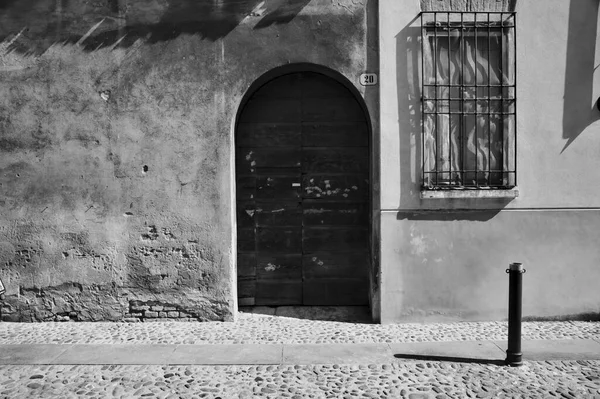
[168,344,283,365]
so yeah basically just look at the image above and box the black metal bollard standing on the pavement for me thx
[506,263,525,367]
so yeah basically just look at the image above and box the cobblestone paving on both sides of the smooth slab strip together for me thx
[0,314,600,399]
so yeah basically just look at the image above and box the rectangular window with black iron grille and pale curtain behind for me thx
[420,12,517,190]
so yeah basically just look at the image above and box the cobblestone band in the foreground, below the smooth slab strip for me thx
[0,361,600,399]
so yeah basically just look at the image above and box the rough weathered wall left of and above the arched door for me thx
[0,0,366,321]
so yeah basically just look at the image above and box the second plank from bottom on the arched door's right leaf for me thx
[302,255,369,281]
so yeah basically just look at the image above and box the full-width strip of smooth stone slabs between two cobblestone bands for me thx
[0,339,600,365]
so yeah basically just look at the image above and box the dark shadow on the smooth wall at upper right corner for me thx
[561,0,600,153]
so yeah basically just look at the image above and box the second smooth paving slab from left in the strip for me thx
[52,344,175,364]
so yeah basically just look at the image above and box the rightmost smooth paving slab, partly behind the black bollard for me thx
[494,339,600,361]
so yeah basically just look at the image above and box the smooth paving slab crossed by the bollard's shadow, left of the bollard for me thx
[389,341,506,360]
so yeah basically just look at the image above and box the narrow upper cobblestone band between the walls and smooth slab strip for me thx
[0,313,600,344]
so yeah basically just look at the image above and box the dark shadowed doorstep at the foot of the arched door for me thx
[239,306,373,324]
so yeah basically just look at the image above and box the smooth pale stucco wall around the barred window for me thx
[379,0,600,322]
